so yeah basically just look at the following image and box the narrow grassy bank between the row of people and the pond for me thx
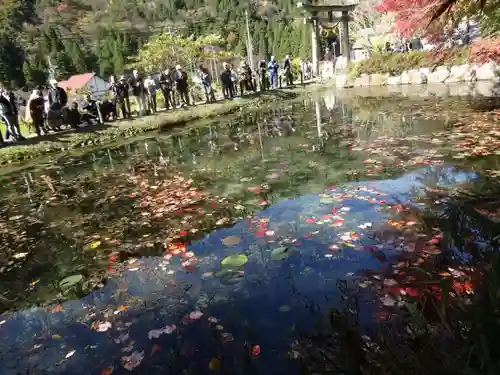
[0,84,325,164]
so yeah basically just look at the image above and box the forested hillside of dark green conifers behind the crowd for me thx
[0,0,310,87]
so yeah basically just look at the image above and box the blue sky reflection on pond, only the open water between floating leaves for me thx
[0,167,475,375]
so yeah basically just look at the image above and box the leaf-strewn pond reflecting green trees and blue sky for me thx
[0,89,497,375]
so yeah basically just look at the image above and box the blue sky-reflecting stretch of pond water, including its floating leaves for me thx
[0,167,475,375]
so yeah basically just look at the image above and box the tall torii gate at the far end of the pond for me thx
[297,0,359,75]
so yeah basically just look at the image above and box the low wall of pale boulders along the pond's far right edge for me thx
[335,62,500,96]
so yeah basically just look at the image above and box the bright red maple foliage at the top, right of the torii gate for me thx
[375,0,450,39]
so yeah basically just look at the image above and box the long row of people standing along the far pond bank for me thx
[0,56,310,144]
